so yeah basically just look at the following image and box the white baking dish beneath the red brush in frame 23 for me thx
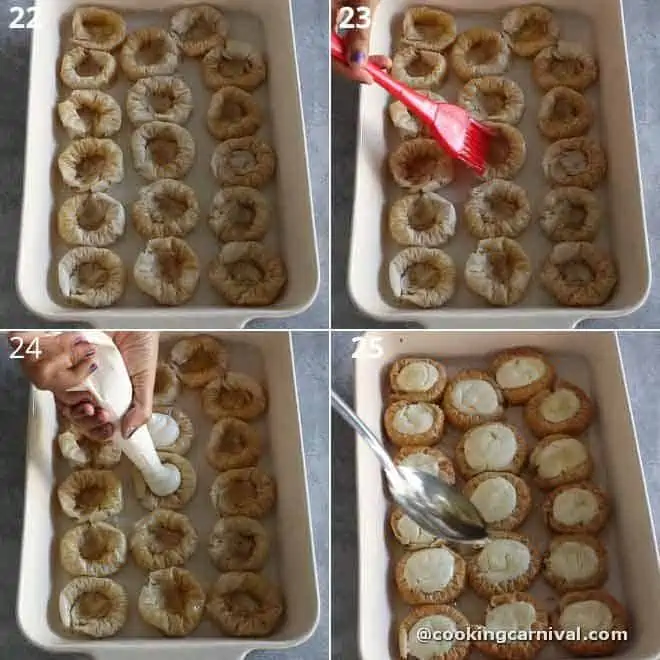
[347,0,651,328]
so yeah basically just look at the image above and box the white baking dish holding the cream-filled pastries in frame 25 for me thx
[355,332,660,660]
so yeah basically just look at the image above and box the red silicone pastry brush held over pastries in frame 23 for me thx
[331,32,493,176]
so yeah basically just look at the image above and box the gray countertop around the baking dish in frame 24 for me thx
[0,332,329,660]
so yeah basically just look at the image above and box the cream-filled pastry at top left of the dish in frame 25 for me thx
[389,357,447,401]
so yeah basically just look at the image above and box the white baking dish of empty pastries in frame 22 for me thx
[16,0,319,329]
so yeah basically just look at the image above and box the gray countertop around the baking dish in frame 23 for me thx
[331,0,660,328]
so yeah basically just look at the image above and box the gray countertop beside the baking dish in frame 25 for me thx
[331,332,660,660]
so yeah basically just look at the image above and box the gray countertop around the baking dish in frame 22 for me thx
[0,0,329,329]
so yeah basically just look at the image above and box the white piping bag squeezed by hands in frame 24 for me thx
[71,330,181,497]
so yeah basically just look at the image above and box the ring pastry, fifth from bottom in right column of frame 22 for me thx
[202,39,266,92]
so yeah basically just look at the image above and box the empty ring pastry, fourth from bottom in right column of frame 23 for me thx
[539,87,594,140]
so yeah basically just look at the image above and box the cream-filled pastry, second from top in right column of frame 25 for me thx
[525,380,595,438]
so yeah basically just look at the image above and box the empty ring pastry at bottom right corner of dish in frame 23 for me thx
[540,242,619,307]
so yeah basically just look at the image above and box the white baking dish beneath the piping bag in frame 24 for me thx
[17,332,319,660]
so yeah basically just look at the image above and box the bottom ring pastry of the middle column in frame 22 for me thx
[133,236,199,305]
